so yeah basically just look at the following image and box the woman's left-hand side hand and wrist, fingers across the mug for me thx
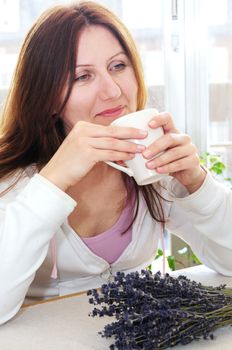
[40,121,147,191]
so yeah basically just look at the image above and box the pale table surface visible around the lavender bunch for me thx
[0,265,232,350]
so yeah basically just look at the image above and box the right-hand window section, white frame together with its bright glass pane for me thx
[181,0,232,177]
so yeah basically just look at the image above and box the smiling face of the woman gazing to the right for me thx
[62,25,138,131]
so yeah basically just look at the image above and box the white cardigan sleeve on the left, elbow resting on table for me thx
[0,174,76,324]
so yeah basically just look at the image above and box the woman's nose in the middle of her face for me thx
[99,74,122,100]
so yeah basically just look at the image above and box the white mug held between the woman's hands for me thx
[106,108,168,186]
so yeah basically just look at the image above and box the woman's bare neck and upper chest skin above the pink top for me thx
[68,164,127,237]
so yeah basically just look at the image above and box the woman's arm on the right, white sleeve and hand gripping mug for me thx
[143,113,232,275]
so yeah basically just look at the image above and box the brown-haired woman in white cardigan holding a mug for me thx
[0,2,232,323]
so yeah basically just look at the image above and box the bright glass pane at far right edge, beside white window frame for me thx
[207,0,232,176]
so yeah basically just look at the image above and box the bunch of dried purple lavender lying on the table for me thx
[87,270,232,350]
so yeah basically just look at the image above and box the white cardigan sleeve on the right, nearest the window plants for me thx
[164,173,232,276]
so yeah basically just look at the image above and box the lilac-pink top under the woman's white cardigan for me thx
[82,187,135,264]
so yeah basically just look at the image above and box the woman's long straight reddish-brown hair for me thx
[0,1,167,222]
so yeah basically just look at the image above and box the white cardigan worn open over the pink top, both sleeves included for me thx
[0,169,232,324]
